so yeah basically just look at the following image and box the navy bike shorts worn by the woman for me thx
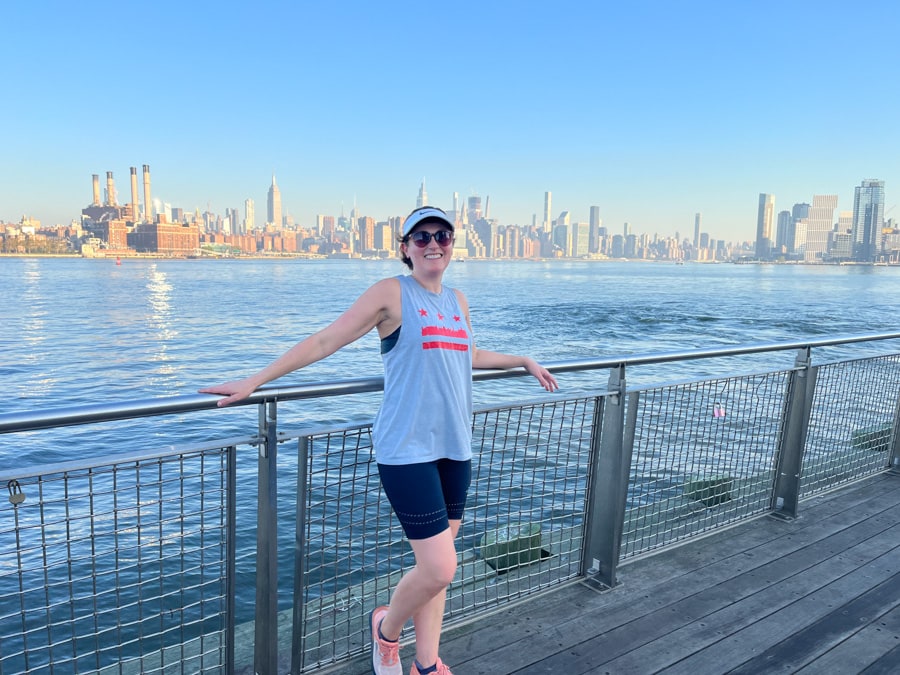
[378,459,472,539]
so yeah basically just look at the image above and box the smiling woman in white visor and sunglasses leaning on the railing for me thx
[200,206,557,675]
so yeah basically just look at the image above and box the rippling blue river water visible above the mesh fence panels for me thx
[0,258,900,470]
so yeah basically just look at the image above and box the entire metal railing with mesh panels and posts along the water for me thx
[0,334,900,673]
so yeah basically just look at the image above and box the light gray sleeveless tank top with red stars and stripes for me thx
[372,275,473,464]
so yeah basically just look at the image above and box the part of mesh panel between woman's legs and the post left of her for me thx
[294,426,394,669]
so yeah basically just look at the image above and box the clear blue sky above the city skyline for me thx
[0,0,900,240]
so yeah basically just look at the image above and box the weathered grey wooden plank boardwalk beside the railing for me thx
[321,474,900,675]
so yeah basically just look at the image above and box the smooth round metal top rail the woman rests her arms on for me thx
[0,333,900,434]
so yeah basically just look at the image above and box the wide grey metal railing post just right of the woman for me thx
[581,365,628,588]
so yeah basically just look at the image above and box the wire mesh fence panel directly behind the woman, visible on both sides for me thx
[295,398,593,670]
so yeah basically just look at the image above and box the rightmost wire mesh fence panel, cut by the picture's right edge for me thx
[800,355,900,497]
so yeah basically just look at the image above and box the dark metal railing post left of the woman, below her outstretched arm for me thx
[253,401,278,675]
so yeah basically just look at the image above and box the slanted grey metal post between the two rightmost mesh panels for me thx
[772,347,818,519]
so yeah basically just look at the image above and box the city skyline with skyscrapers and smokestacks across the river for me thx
[7,172,900,264]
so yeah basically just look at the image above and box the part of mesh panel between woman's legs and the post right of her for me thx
[460,397,594,604]
